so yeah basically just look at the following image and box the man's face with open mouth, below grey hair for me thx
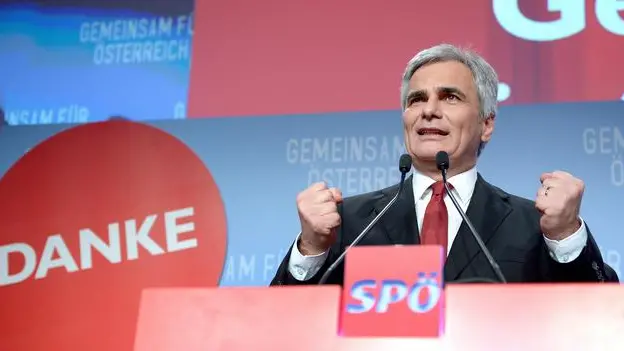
[403,61,494,172]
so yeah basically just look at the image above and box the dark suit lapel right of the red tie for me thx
[444,174,512,280]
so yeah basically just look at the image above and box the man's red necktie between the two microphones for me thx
[421,181,448,256]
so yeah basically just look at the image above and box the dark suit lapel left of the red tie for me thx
[375,176,420,245]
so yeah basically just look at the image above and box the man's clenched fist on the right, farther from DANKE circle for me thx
[535,171,585,240]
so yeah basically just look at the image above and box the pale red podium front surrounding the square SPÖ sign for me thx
[135,284,624,351]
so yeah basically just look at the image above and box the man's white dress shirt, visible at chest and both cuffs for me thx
[288,168,587,281]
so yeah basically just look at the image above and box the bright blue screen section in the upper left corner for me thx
[0,0,194,125]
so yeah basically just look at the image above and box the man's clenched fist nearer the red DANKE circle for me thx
[297,182,342,255]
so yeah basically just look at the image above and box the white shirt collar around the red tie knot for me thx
[412,167,477,204]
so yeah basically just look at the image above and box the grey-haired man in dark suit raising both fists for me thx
[271,44,618,285]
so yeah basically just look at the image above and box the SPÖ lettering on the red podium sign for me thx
[346,272,442,313]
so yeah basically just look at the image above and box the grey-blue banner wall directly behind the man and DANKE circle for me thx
[0,102,624,286]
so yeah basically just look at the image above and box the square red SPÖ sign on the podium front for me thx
[339,245,445,337]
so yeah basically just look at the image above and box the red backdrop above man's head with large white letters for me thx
[188,0,624,117]
